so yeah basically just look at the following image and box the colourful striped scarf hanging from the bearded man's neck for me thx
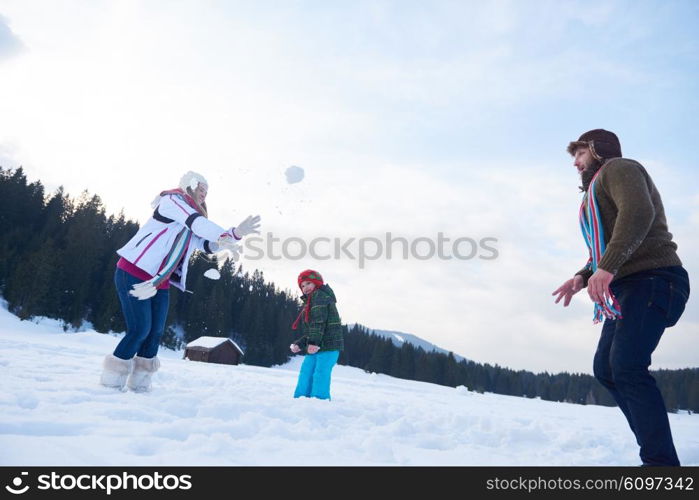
[580,169,621,324]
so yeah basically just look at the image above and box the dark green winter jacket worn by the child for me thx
[296,285,345,351]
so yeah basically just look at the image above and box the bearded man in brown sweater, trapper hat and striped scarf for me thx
[553,129,689,465]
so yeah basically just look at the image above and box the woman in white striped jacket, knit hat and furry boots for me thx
[101,172,260,392]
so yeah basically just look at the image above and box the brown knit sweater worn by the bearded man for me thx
[576,158,682,286]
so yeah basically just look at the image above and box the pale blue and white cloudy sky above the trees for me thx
[0,0,699,373]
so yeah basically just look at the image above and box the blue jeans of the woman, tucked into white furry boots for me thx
[114,268,170,359]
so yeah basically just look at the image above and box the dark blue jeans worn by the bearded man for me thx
[594,266,689,465]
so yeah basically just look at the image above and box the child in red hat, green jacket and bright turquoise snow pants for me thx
[290,269,344,399]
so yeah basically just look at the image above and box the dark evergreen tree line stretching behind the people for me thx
[0,167,699,412]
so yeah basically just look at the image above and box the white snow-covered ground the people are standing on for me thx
[0,307,699,466]
